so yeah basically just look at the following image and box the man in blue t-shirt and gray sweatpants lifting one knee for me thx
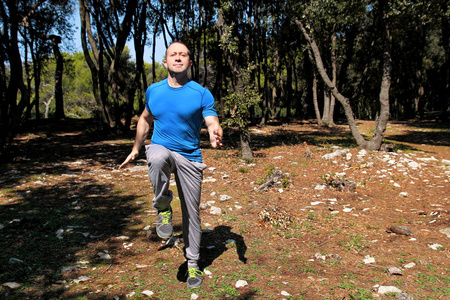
[119,42,223,288]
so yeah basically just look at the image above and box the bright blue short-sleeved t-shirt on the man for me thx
[145,79,217,162]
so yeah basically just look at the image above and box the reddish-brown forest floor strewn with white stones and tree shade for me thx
[0,120,450,299]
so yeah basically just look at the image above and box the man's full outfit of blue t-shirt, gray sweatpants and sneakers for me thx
[145,79,217,276]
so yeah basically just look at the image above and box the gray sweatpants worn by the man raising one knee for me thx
[145,144,206,267]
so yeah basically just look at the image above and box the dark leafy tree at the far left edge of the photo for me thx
[0,0,72,155]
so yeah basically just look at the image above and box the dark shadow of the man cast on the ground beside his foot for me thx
[177,225,247,282]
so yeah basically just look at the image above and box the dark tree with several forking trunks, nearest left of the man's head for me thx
[79,0,138,130]
